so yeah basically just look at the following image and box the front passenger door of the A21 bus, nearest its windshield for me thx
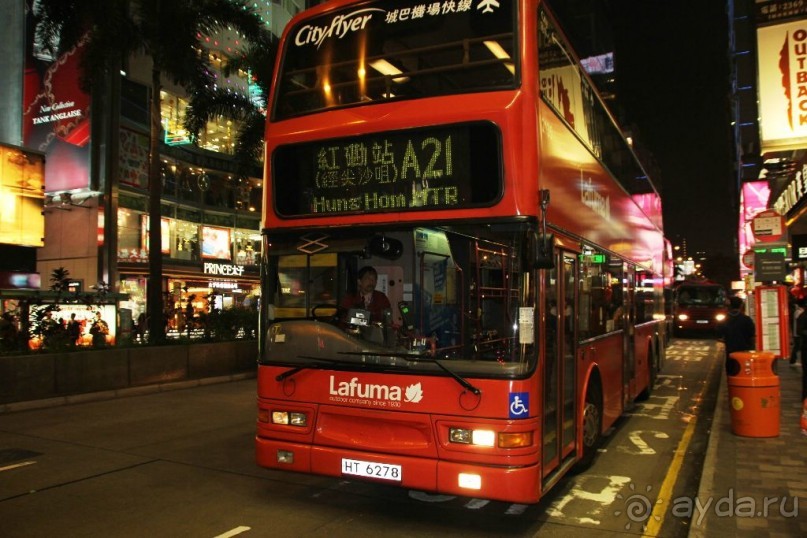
[542,252,577,476]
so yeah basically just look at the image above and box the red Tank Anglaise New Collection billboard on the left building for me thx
[23,0,90,193]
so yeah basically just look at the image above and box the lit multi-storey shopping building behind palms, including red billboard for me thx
[0,0,306,336]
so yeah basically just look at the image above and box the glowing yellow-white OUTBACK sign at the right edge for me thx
[757,20,807,153]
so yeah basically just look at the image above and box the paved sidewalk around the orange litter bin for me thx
[689,354,807,538]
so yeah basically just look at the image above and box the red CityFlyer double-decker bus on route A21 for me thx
[256,0,669,503]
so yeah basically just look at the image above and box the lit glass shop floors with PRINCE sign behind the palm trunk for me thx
[117,92,262,341]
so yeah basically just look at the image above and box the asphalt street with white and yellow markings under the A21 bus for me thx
[0,339,722,538]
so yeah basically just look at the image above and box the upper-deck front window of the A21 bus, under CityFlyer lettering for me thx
[273,0,518,120]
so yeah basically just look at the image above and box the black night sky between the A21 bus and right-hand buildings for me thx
[610,0,737,256]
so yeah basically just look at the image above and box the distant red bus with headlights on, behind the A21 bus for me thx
[672,280,729,336]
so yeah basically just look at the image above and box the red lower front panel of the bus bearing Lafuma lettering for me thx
[256,365,541,502]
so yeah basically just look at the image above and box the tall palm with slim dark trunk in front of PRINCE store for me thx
[35,0,271,343]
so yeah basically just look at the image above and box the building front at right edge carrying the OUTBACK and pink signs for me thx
[727,0,807,283]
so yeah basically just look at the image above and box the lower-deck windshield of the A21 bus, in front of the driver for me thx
[262,225,535,377]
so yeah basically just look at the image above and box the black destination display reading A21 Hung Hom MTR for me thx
[272,124,501,216]
